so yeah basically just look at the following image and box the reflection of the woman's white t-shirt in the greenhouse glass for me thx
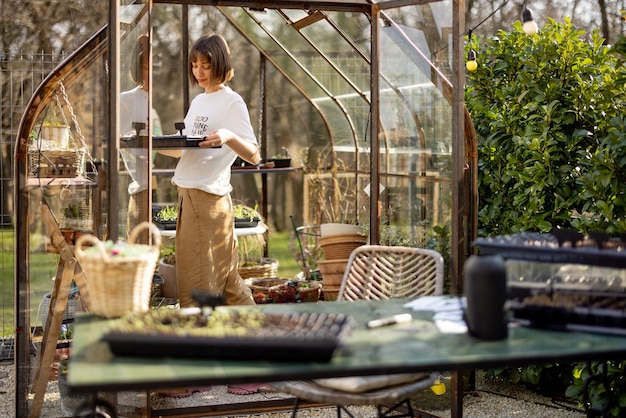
[120,87,163,195]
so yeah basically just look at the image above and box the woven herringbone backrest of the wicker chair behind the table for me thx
[337,245,444,300]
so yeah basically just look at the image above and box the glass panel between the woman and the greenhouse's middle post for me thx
[219,9,369,229]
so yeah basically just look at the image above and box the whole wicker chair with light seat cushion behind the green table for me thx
[274,245,444,418]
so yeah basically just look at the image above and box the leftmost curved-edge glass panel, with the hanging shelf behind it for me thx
[25,37,108,327]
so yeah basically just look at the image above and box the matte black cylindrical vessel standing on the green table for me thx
[463,255,508,340]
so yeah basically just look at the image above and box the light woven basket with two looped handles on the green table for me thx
[76,222,161,318]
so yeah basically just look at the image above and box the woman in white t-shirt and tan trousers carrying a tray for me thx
[167,34,260,307]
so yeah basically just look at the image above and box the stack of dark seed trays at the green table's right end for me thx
[474,231,626,335]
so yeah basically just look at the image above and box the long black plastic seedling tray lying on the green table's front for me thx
[103,313,350,362]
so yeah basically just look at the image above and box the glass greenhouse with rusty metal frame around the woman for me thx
[15,0,476,416]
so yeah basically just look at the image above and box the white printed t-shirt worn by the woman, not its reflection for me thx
[172,87,258,196]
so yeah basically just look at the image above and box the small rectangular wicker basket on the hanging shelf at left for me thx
[28,149,85,177]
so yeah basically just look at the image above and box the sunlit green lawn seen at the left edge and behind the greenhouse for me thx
[0,229,301,336]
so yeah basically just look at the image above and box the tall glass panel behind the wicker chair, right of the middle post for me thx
[380,2,452,247]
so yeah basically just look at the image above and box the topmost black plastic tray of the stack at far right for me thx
[472,233,626,268]
